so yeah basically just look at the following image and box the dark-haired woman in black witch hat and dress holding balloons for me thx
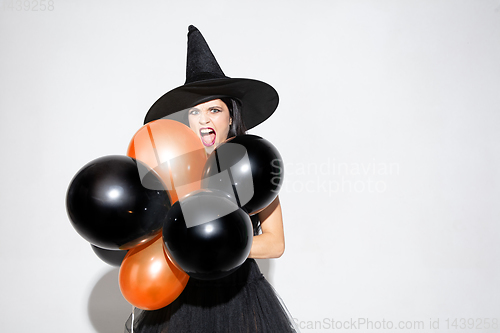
[125,26,298,333]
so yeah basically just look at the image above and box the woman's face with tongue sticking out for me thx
[188,99,232,154]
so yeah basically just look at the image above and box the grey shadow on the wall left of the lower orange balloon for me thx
[87,268,132,333]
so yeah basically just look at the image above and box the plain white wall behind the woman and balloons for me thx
[0,0,500,333]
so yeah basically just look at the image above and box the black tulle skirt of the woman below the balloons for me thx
[125,259,298,333]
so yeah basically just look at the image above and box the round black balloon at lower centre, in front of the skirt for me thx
[163,190,253,280]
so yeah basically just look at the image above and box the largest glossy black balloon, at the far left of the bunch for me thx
[66,155,170,250]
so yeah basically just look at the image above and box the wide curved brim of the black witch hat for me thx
[144,78,279,129]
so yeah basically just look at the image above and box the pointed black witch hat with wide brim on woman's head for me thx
[144,25,279,129]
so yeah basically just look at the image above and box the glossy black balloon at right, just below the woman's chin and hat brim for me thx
[202,135,283,215]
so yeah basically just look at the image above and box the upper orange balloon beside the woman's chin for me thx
[127,119,207,203]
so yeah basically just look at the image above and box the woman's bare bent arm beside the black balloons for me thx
[248,197,285,259]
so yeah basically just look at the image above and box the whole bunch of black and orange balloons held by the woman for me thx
[66,119,283,310]
